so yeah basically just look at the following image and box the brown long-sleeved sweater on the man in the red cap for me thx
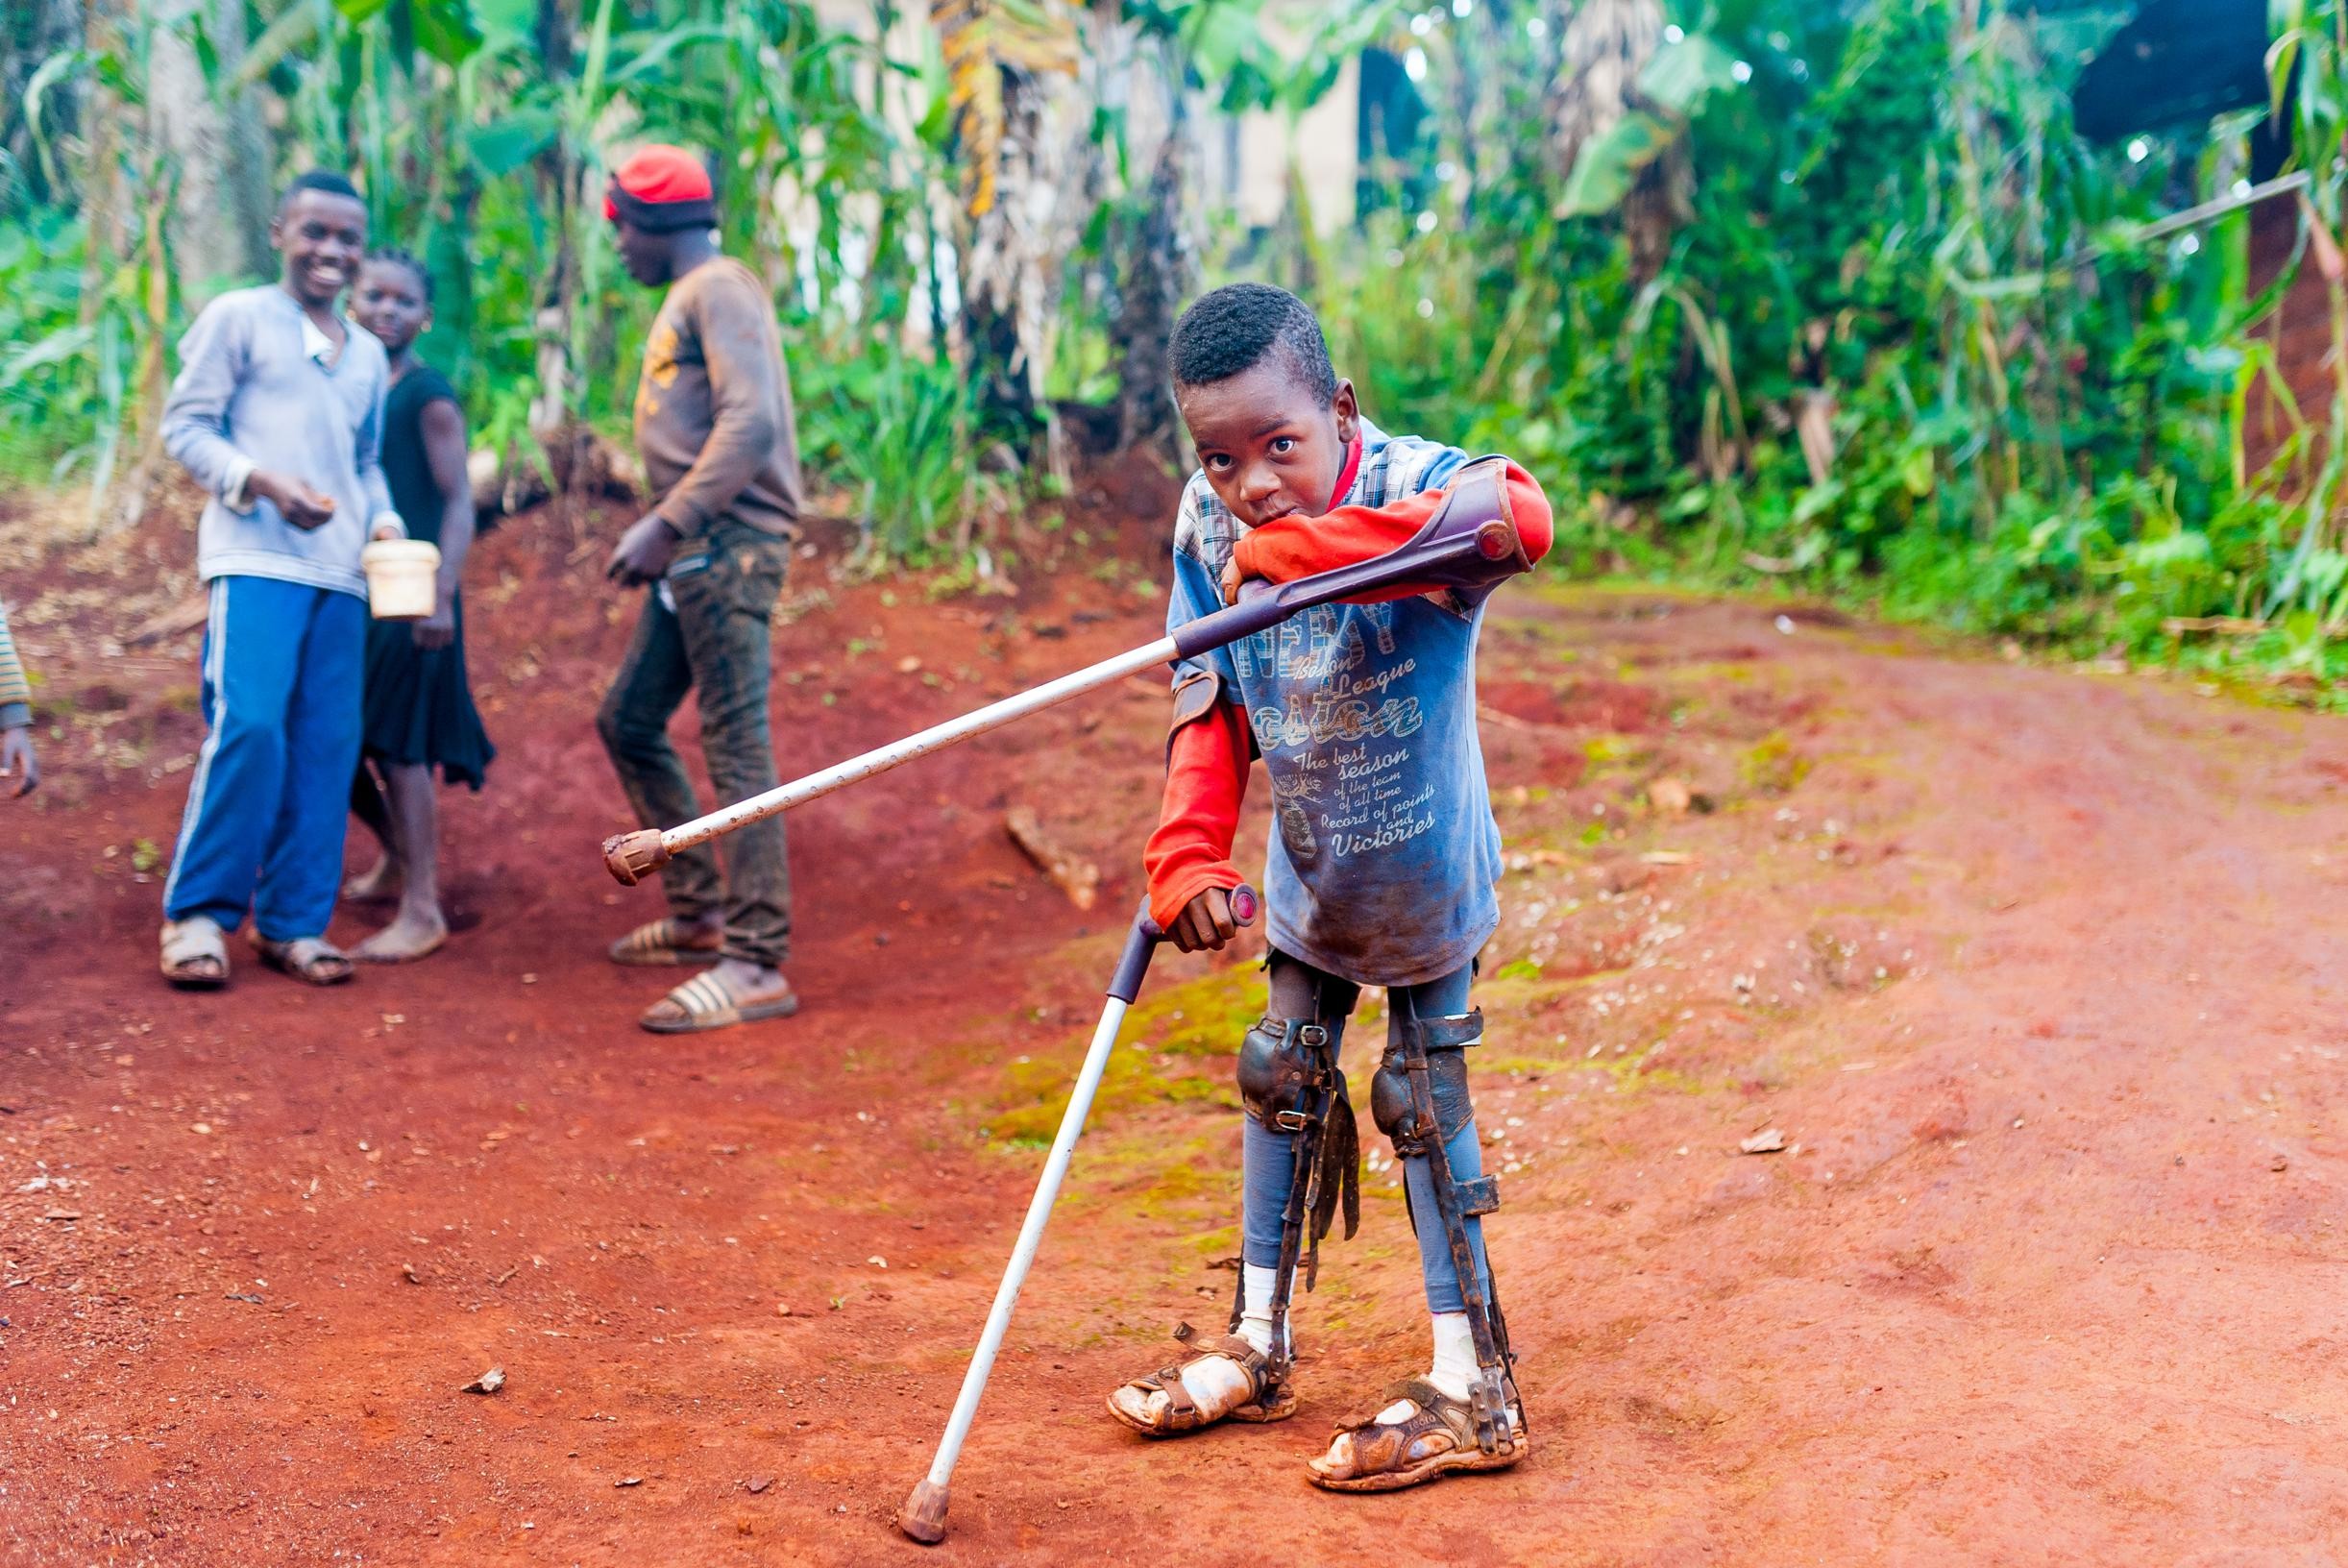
[636,256,798,537]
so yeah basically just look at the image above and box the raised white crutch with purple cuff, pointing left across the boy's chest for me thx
[603,457,1530,887]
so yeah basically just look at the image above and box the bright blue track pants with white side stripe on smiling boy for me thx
[162,577,366,942]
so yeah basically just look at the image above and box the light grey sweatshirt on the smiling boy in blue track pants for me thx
[162,284,399,599]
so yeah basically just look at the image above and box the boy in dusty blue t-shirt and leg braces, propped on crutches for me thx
[1109,284,1550,1490]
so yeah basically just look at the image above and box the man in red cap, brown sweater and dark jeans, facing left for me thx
[597,145,798,1035]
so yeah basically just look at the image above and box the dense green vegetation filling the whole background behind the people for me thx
[0,0,2348,701]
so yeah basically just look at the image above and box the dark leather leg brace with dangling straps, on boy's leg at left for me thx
[1231,1004,1362,1384]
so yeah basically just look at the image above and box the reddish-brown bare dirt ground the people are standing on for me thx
[0,509,2348,1566]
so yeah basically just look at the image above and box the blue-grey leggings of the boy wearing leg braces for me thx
[1239,950,1491,1312]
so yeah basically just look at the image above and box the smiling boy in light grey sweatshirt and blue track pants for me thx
[162,174,404,989]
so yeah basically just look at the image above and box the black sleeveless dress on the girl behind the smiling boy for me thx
[364,364,498,789]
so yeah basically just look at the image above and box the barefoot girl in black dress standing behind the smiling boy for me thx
[343,251,496,965]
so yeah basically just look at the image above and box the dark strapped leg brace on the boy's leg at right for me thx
[1369,989,1522,1453]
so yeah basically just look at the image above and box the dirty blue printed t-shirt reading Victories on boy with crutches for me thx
[1167,420,1501,986]
